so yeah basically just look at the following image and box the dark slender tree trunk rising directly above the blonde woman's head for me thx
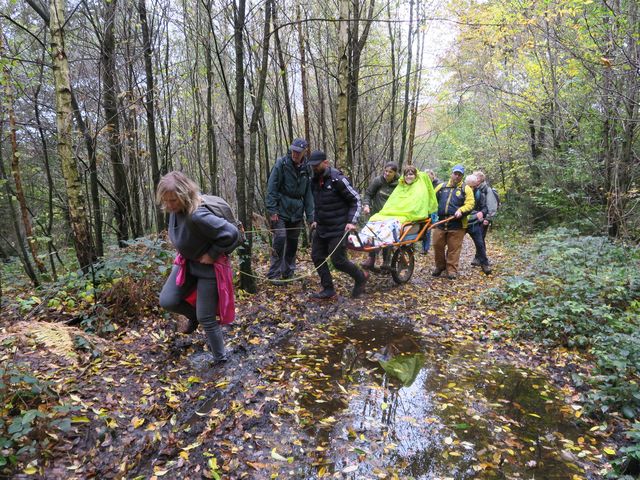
[138,0,166,232]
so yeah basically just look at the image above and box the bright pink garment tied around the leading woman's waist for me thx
[173,254,236,325]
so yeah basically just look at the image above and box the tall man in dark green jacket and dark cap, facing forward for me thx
[266,138,313,283]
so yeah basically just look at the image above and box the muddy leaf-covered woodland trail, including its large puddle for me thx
[4,245,609,480]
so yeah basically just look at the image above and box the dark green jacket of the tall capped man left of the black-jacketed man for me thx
[266,155,313,222]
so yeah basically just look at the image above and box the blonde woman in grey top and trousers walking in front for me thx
[156,171,240,365]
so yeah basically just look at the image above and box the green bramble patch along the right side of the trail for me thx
[487,229,640,476]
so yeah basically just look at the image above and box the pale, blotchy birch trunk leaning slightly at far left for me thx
[49,0,96,272]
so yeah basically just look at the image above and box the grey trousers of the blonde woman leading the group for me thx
[160,262,225,360]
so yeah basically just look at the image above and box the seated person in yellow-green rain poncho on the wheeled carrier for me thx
[349,165,438,255]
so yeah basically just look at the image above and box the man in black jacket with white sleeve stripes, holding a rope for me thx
[309,150,367,300]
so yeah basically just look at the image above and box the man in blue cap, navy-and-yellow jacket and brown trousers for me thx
[432,165,475,280]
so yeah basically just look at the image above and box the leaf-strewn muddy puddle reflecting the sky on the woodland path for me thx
[280,318,596,479]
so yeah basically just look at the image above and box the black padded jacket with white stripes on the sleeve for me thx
[311,168,362,238]
